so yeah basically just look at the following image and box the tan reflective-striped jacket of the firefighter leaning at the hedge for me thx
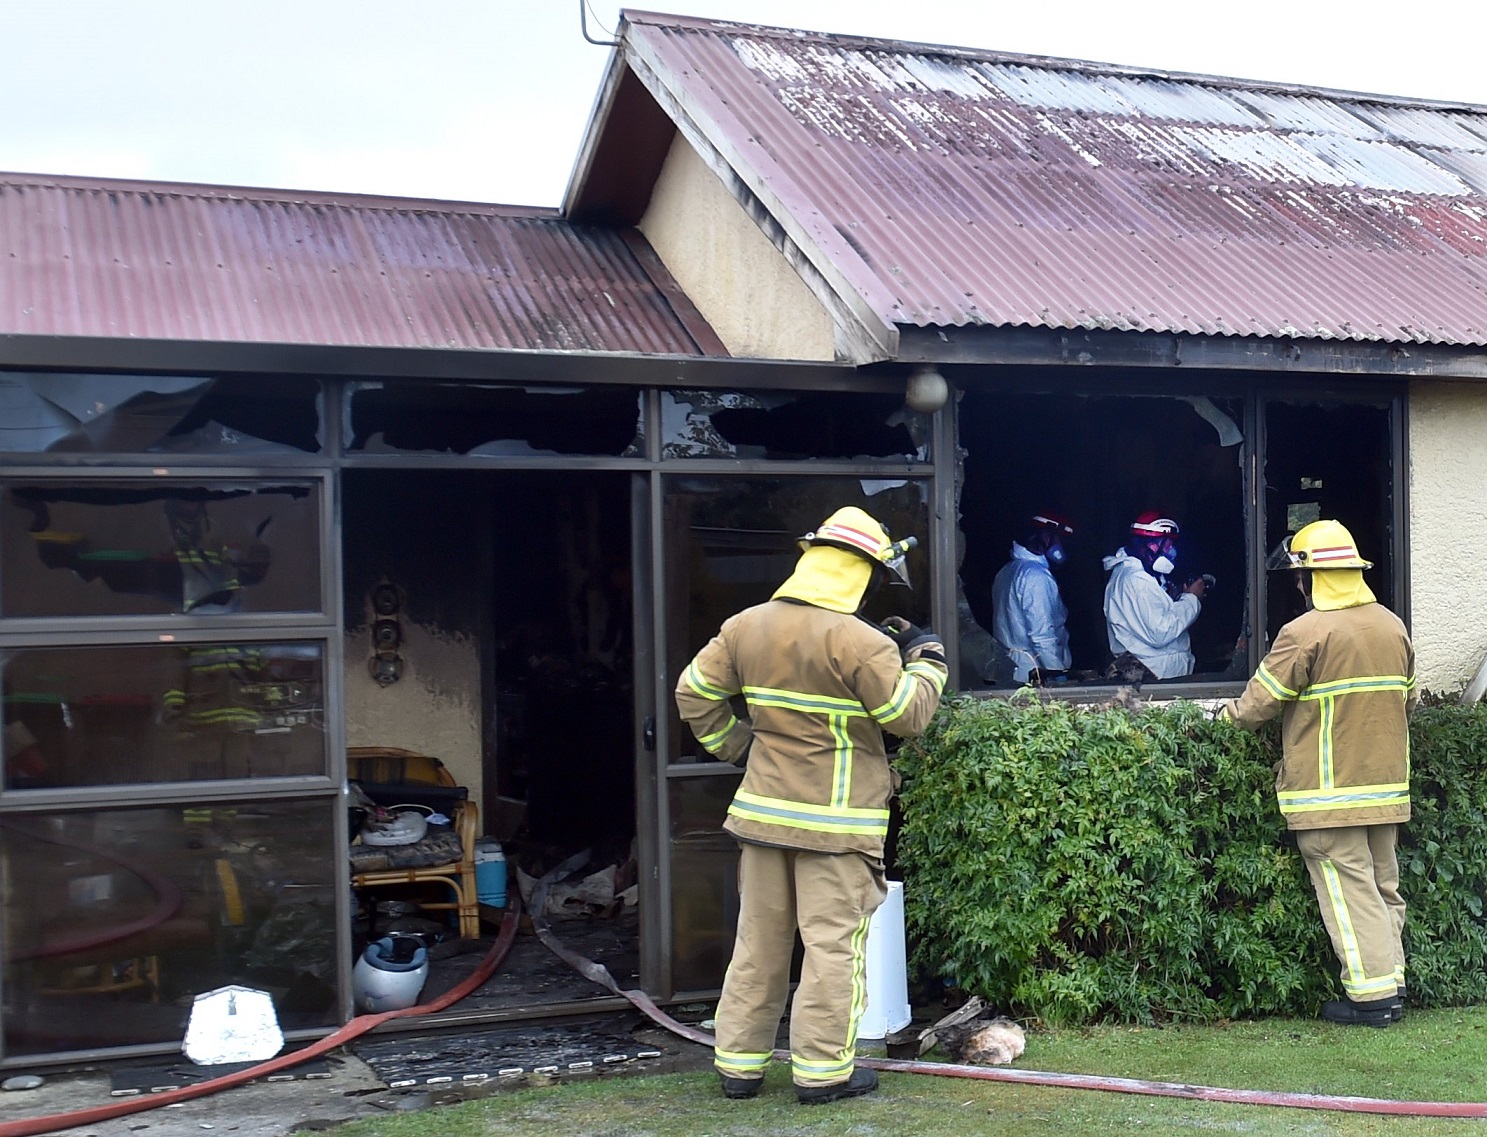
[1225,603,1419,829]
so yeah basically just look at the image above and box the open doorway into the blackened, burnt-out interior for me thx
[342,470,639,1011]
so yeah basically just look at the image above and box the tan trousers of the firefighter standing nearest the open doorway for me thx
[714,843,888,1086]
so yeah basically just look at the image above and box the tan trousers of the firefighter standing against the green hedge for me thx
[1297,825,1404,1003]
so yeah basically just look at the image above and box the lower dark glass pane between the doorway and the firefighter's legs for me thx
[668,776,739,991]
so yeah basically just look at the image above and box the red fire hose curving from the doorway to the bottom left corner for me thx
[0,889,522,1137]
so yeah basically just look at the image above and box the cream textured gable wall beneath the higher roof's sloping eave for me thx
[639,134,836,360]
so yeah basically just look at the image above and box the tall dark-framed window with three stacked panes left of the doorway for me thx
[0,452,349,1067]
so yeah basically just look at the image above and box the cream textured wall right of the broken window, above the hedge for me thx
[1408,382,1487,691]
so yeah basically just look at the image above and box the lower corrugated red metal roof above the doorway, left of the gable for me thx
[0,174,718,355]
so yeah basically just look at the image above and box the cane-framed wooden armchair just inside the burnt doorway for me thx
[346,746,480,939]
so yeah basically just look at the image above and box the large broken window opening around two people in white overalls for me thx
[959,391,1251,687]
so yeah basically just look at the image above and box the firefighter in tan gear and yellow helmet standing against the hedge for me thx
[1221,520,1417,1027]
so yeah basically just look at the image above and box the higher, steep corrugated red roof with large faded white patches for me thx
[625,12,1487,345]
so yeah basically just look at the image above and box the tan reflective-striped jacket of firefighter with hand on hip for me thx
[677,600,946,858]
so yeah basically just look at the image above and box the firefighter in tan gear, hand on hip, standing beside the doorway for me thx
[677,507,947,1103]
